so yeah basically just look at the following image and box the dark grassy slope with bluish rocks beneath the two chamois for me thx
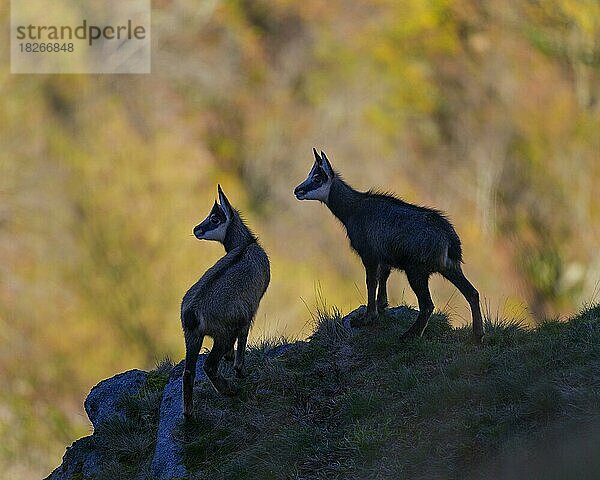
[48,306,600,480]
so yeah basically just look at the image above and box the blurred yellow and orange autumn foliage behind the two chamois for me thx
[0,0,600,478]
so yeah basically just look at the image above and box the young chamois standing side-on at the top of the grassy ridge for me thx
[294,148,483,343]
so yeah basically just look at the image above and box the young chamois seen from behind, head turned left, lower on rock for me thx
[181,185,270,417]
